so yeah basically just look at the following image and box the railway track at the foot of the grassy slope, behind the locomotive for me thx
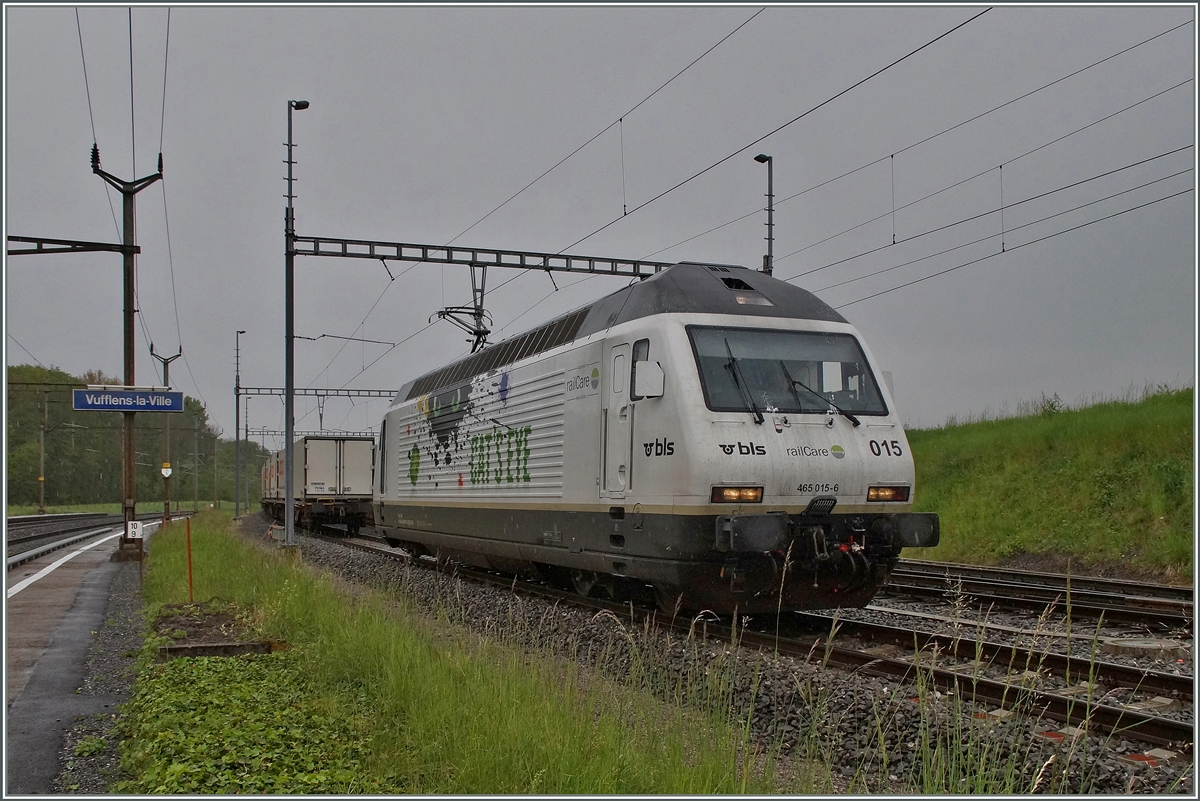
[883,560,1195,630]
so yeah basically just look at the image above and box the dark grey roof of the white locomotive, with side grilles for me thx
[394,261,846,403]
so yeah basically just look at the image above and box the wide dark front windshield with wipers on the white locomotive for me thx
[688,326,888,415]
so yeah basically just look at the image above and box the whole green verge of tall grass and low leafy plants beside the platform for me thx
[114,513,778,795]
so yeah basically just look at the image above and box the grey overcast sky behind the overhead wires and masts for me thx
[4,5,1196,446]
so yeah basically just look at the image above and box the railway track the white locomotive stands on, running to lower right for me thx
[314,530,1194,747]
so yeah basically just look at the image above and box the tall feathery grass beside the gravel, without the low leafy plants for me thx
[133,513,776,795]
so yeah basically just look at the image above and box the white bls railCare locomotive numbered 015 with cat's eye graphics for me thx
[374,263,938,613]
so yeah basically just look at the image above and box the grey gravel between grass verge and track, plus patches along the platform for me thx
[55,514,1194,795]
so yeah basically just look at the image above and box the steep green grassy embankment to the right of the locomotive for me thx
[905,389,1194,578]
